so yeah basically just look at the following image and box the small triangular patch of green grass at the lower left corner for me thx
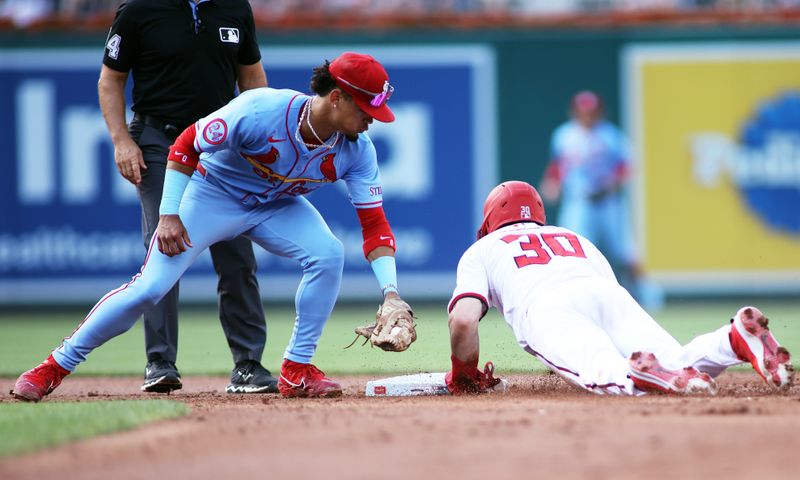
[0,400,190,458]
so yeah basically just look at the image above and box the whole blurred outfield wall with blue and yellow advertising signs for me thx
[0,0,800,304]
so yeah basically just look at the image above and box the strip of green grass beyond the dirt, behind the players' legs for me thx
[0,301,800,377]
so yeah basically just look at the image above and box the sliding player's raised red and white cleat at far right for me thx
[728,307,794,388]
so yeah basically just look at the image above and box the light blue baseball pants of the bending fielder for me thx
[53,173,344,371]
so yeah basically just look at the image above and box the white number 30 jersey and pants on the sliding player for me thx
[449,223,739,395]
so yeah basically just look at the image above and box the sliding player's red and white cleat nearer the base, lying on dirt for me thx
[630,352,717,395]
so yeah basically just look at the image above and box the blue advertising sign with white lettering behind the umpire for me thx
[0,45,497,304]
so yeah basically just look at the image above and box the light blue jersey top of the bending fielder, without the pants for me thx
[195,88,383,208]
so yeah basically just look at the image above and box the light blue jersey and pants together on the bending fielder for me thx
[53,88,390,371]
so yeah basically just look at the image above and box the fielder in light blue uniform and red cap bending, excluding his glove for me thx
[15,53,410,401]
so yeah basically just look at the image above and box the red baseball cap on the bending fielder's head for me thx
[328,52,394,123]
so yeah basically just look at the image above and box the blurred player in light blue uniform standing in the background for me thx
[540,91,663,310]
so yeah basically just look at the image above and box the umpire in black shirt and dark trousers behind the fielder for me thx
[98,0,278,393]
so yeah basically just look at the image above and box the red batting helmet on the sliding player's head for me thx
[478,180,545,240]
